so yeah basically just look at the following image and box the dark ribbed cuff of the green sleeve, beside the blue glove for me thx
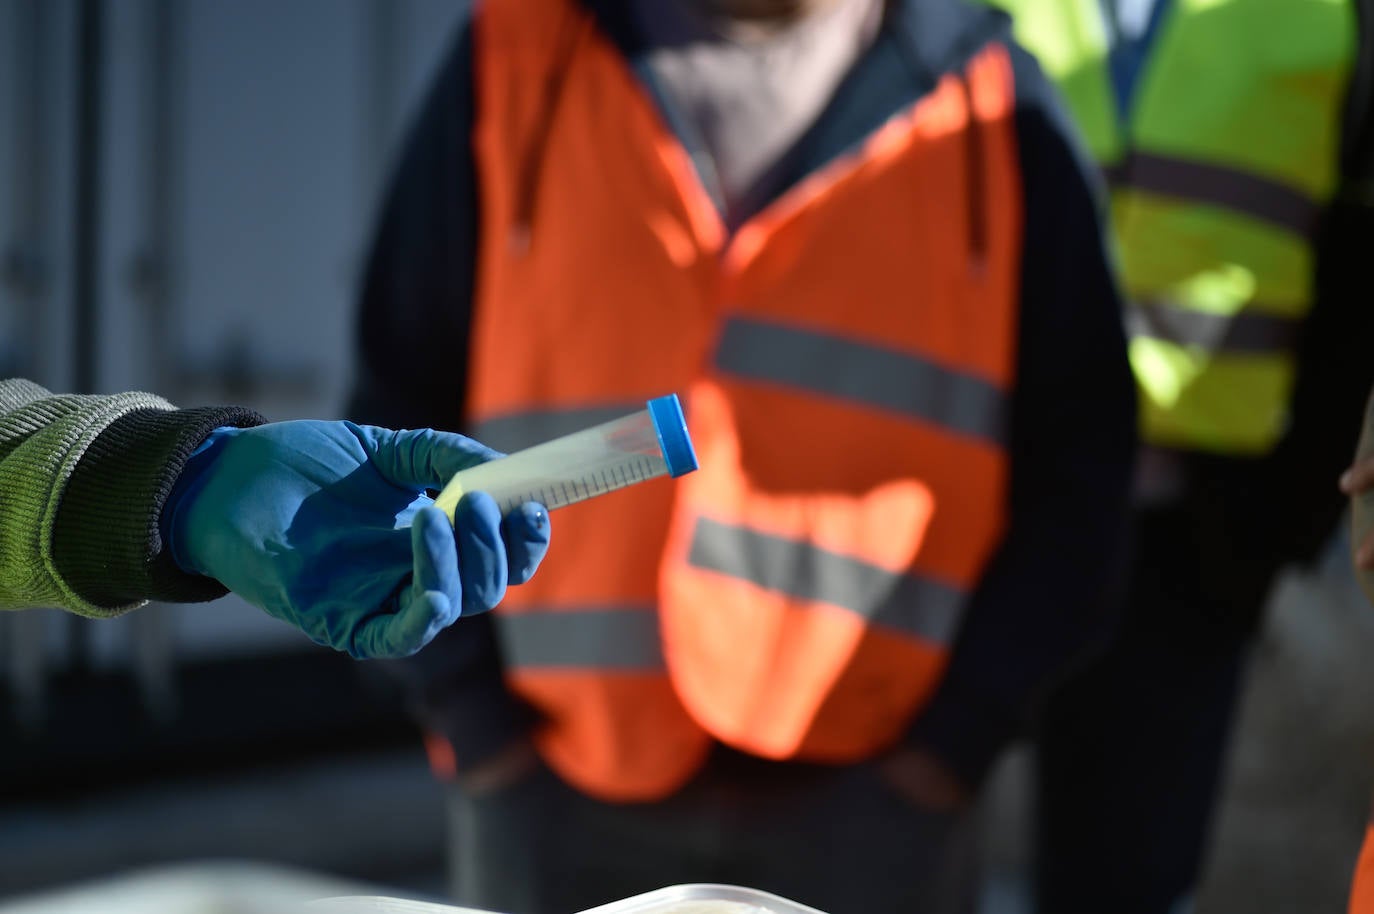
[52,407,267,608]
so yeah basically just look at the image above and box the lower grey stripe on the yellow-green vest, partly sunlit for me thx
[1127,301,1303,355]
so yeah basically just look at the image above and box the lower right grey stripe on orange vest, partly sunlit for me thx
[687,518,966,645]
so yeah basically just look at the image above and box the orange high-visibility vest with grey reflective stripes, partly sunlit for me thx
[469,0,1021,801]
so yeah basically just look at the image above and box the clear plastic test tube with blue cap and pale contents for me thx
[434,393,697,520]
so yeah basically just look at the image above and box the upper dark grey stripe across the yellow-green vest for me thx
[1102,151,1320,238]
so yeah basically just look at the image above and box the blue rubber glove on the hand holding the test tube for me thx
[162,421,550,658]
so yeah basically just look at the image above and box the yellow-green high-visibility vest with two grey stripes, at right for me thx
[992,0,1356,455]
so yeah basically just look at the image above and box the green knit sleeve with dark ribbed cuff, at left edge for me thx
[0,379,262,616]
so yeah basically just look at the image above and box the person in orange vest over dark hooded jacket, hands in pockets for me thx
[352,0,1135,914]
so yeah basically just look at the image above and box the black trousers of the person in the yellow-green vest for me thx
[1036,503,1276,914]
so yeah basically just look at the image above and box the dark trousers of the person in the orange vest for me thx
[449,749,977,914]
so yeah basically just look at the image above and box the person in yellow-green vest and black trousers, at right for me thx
[995,0,1374,914]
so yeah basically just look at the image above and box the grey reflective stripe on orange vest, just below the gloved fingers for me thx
[496,606,664,672]
